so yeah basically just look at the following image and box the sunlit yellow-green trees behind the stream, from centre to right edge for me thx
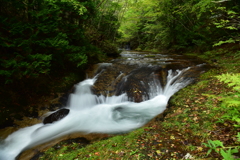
[118,0,240,52]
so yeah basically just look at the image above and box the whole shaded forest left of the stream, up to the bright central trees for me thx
[0,0,121,121]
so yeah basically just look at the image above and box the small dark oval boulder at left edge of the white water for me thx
[43,108,70,124]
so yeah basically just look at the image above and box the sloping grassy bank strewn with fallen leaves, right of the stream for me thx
[39,47,240,160]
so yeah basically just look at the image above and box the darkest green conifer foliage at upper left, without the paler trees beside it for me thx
[0,0,102,83]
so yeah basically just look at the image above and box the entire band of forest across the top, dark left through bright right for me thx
[0,0,240,84]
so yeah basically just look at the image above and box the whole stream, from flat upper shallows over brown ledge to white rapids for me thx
[0,51,205,160]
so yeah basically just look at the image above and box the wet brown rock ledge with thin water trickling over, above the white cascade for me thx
[91,52,209,103]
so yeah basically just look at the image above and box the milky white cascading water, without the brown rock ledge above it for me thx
[0,69,190,160]
